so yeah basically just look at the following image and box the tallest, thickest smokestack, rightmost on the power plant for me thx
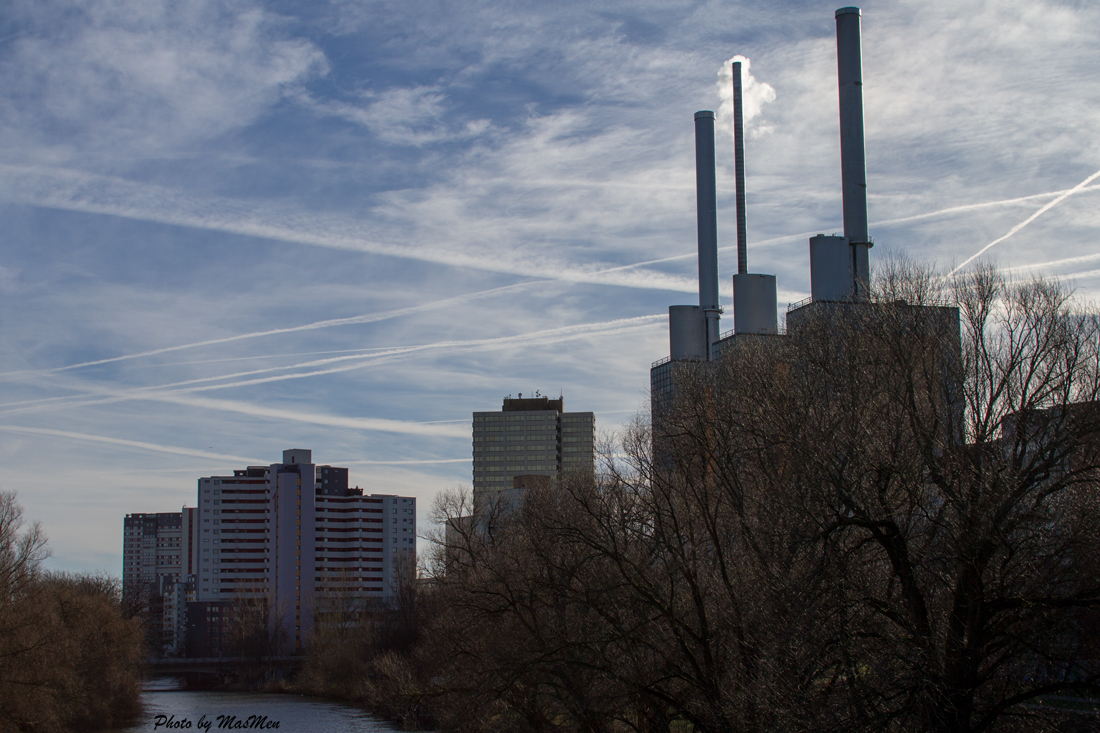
[836,8,872,300]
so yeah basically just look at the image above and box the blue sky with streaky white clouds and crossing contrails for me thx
[0,0,1100,573]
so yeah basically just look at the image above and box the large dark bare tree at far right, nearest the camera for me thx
[783,269,1100,732]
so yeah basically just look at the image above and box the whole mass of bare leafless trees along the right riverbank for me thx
[393,261,1100,733]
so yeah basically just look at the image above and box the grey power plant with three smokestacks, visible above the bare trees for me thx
[650,8,959,416]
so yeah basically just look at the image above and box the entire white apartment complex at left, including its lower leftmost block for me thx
[123,449,416,656]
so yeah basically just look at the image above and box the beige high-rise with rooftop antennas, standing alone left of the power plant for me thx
[473,395,595,497]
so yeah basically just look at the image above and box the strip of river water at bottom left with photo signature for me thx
[118,686,398,733]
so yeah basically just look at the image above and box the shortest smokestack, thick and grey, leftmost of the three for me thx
[695,110,722,359]
